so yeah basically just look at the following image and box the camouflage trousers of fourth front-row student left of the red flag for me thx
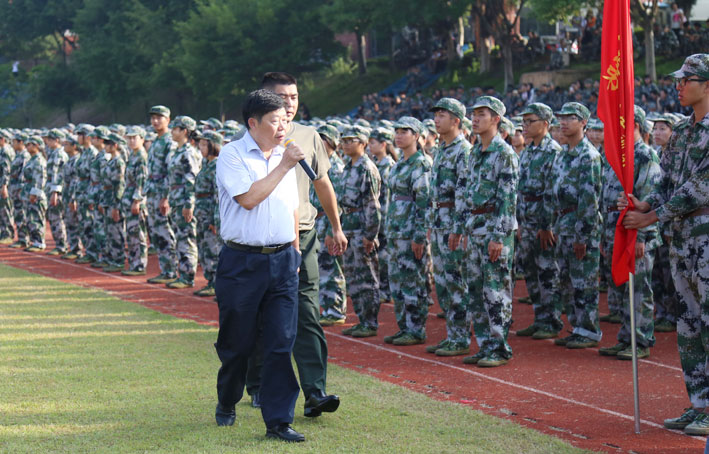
[431,229,470,347]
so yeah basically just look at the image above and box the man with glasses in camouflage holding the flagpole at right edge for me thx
[618,54,709,435]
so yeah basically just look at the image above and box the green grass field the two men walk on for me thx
[0,265,596,454]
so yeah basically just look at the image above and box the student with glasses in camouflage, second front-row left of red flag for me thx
[516,103,564,339]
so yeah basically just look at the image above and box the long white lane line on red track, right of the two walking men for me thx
[328,332,668,433]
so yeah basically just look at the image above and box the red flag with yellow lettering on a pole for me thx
[598,0,638,285]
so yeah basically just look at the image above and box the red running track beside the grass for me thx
[0,239,705,454]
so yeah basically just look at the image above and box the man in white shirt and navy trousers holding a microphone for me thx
[215,90,305,441]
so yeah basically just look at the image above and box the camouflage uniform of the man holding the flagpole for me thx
[645,103,709,408]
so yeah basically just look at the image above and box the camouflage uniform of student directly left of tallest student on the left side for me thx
[121,142,148,271]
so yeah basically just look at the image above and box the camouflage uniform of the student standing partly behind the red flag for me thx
[601,135,660,348]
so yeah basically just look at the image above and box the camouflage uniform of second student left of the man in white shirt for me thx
[166,136,201,284]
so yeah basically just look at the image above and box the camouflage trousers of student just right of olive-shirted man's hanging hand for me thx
[342,232,380,329]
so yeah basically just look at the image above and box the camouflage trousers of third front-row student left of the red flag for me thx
[465,233,514,358]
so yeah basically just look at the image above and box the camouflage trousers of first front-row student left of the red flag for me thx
[555,233,602,341]
